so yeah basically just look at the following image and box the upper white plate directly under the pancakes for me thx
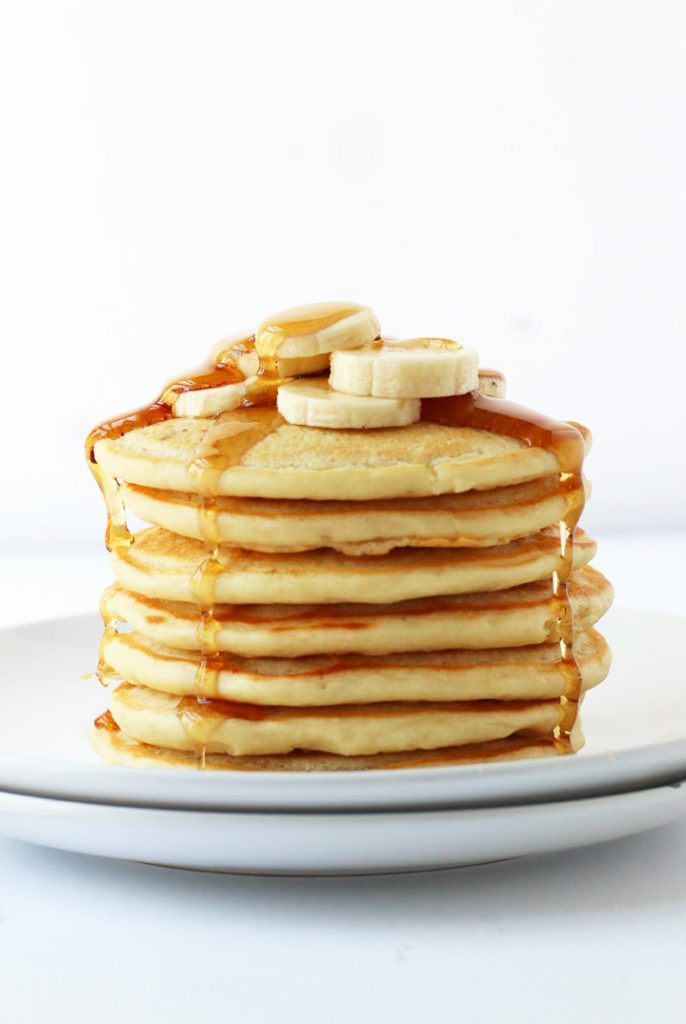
[0,611,686,812]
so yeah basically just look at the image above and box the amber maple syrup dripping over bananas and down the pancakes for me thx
[85,303,585,765]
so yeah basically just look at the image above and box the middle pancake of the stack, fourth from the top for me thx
[101,566,613,657]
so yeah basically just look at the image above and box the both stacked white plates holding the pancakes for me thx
[0,611,686,874]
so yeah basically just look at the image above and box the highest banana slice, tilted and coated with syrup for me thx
[255,302,381,373]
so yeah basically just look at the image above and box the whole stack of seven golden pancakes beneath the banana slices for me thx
[92,387,612,770]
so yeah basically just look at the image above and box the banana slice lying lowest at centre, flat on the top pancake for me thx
[276,378,421,430]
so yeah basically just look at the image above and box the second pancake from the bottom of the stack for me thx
[109,683,572,757]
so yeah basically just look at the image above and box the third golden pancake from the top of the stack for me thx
[111,526,596,606]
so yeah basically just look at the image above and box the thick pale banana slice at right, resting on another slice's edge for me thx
[329,338,478,398]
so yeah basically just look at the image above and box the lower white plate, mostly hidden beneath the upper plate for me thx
[0,783,686,874]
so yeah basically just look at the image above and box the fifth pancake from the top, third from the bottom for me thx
[101,630,610,708]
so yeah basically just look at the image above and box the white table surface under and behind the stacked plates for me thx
[0,535,686,1024]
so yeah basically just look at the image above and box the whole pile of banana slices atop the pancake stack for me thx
[163,311,489,429]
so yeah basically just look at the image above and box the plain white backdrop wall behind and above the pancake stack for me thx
[0,0,686,548]
